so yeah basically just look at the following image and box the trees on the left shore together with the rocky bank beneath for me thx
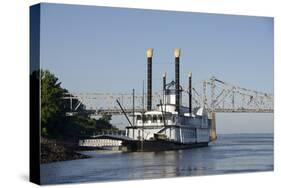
[30,70,118,163]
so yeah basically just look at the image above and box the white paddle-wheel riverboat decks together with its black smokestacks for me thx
[123,48,216,145]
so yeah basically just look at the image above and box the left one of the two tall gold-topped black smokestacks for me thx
[146,48,153,111]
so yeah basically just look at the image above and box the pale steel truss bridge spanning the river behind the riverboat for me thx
[64,77,274,115]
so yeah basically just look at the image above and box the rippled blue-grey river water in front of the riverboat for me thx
[41,134,274,184]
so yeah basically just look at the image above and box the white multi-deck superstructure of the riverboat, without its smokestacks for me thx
[126,82,211,144]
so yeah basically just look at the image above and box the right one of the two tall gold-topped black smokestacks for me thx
[174,48,180,115]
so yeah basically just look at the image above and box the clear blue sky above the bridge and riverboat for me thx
[38,4,274,132]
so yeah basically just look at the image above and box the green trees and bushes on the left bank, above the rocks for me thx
[41,70,117,139]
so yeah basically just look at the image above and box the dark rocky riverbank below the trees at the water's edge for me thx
[41,138,89,163]
